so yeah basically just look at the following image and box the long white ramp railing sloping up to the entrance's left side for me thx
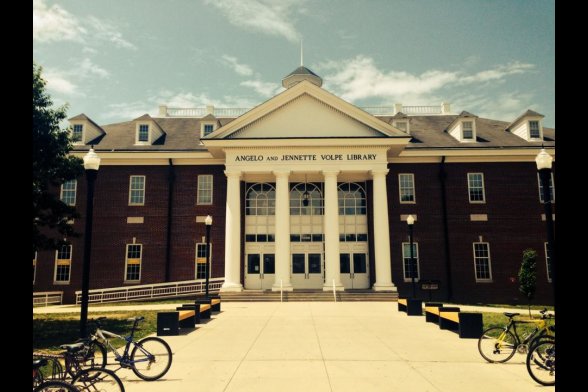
[76,277,225,304]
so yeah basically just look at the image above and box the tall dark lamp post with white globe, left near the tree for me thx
[80,146,100,338]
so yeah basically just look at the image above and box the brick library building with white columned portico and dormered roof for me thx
[33,66,555,304]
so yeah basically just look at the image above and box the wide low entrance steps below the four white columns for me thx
[220,289,398,302]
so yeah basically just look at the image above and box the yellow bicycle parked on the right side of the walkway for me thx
[478,309,553,363]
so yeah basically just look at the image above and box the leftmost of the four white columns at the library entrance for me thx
[220,171,243,291]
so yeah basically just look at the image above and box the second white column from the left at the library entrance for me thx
[272,170,292,291]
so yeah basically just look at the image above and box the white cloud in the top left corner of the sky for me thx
[33,0,136,51]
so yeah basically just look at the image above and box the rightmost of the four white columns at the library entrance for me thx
[371,168,397,291]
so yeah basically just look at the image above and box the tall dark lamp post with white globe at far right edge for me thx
[535,148,556,309]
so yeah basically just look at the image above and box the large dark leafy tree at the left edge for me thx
[32,62,83,252]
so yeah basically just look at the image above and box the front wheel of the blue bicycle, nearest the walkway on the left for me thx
[131,337,172,381]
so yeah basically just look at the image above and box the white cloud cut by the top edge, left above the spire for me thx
[206,0,305,42]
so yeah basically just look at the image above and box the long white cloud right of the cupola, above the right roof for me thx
[318,55,534,105]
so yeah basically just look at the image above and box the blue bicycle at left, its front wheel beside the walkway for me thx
[82,317,172,381]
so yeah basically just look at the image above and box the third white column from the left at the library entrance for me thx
[323,170,344,291]
